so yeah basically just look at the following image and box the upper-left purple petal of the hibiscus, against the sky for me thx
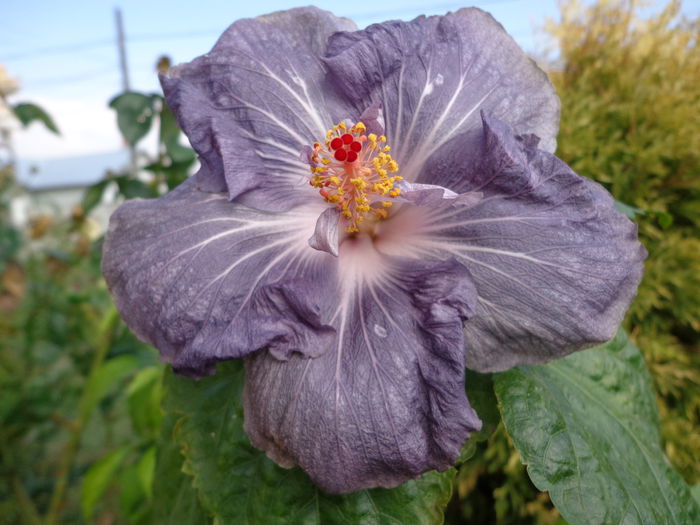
[161,7,355,211]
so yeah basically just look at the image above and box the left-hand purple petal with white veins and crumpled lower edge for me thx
[103,179,337,377]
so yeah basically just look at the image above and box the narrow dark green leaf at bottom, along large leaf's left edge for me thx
[153,414,213,525]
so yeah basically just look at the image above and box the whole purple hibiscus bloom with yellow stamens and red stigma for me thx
[103,8,645,493]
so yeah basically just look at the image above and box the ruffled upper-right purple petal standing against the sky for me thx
[325,8,559,185]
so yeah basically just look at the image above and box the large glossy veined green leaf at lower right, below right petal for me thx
[495,331,700,525]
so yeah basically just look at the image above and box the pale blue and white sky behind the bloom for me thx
[0,0,700,170]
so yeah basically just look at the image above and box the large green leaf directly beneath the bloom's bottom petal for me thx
[156,362,454,525]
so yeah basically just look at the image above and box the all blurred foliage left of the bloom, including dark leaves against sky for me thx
[0,55,195,525]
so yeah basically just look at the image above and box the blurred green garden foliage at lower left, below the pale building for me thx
[0,167,162,524]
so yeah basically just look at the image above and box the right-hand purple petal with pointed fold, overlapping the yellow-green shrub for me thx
[416,115,646,372]
